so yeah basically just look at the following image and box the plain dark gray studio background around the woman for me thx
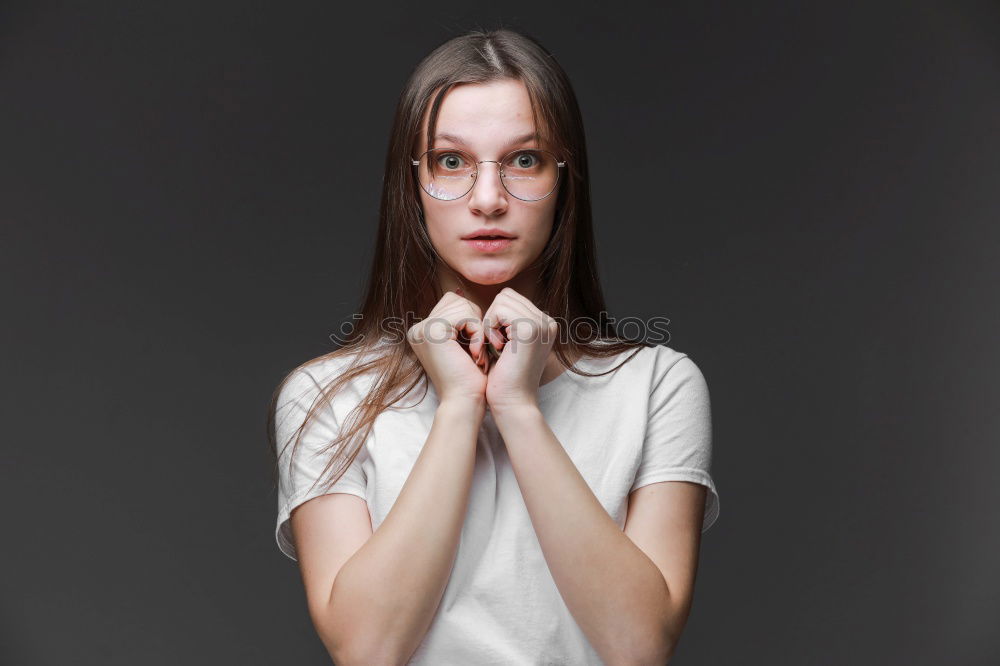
[0,1,1000,665]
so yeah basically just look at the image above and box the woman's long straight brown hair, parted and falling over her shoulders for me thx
[267,29,648,496]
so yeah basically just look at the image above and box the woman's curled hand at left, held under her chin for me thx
[406,291,486,405]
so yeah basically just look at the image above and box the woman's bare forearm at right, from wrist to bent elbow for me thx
[493,407,672,664]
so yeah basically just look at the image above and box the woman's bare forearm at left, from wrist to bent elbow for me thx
[329,396,485,664]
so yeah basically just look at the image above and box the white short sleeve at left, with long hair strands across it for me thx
[274,369,368,561]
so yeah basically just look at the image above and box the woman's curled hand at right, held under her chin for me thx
[483,287,559,411]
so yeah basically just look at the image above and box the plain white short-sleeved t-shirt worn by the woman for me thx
[276,345,719,666]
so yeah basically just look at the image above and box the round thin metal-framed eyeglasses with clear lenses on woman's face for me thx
[410,148,566,201]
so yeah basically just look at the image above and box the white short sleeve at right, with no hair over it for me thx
[629,347,719,532]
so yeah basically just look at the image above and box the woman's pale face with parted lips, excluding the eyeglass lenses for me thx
[415,79,558,285]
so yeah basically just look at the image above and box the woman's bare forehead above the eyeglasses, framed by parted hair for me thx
[420,79,548,152]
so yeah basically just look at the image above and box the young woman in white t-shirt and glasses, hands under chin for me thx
[269,30,719,664]
